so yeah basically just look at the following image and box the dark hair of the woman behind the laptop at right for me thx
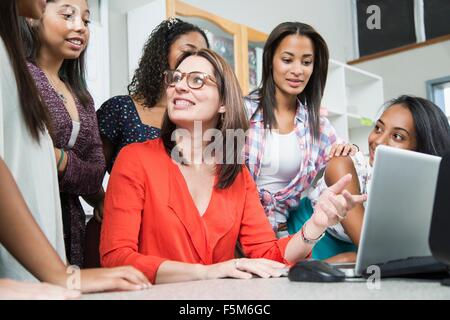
[386,95,450,156]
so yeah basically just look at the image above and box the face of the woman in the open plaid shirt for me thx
[273,34,314,96]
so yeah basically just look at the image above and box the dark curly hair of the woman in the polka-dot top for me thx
[128,18,209,108]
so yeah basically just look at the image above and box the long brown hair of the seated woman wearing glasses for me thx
[161,49,248,189]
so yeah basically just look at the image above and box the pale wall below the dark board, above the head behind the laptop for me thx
[355,41,450,100]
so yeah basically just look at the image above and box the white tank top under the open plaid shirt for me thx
[256,130,303,194]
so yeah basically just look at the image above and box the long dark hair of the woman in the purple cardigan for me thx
[20,0,92,107]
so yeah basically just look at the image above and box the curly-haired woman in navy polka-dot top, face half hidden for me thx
[97,18,209,172]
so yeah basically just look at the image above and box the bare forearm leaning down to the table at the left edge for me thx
[0,159,68,286]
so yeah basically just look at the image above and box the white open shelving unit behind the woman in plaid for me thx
[322,59,384,155]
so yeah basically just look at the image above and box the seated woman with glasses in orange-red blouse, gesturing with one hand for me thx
[100,49,365,283]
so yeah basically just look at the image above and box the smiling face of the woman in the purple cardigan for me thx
[39,0,90,59]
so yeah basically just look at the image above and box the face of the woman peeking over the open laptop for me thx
[369,104,417,166]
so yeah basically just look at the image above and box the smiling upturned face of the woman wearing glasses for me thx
[166,56,225,129]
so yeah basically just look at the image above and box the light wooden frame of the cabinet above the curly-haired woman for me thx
[166,0,267,94]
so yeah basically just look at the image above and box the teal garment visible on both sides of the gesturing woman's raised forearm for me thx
[287,198,358,260]
